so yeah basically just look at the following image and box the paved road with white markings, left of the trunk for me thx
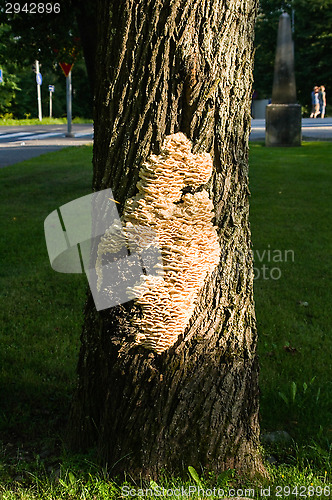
[0,124,93,168]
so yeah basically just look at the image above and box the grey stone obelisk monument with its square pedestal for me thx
[265,13,301,146]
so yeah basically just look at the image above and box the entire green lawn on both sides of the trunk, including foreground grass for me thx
[0,142,332,500]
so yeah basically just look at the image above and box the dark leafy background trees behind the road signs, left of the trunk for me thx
[0,0,94,118]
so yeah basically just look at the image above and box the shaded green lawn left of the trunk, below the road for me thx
[0,147,92,458]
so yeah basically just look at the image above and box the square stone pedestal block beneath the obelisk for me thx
[265,104,302,147]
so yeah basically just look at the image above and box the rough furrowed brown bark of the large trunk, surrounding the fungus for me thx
[69,0,264,477]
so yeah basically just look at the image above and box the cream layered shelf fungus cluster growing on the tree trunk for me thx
[98,132,220,353]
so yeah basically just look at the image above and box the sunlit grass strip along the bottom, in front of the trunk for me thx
[0,461,331,500]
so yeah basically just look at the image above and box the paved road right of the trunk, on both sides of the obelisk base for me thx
[250,118,332,145]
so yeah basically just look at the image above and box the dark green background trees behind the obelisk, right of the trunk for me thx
[254,0,332,111]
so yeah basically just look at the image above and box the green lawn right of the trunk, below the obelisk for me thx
[250,143,332,443]
